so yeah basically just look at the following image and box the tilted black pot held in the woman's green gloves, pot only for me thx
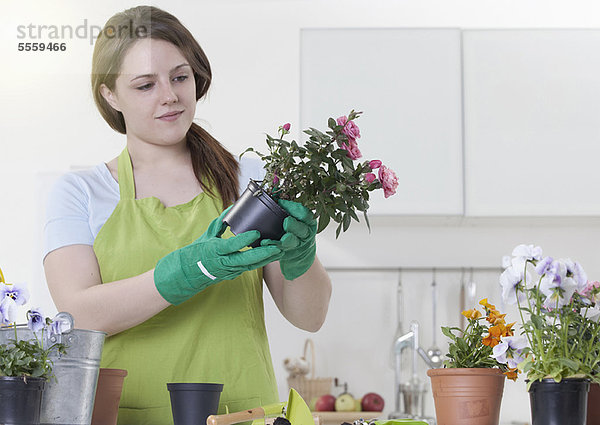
[223,180,289,248]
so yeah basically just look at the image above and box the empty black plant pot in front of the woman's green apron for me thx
[167,383,223,425]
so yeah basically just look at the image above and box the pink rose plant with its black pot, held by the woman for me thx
[223,110,398,246]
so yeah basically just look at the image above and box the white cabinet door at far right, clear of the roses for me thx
[463,29,600,216]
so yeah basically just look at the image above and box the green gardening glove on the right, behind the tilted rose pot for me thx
[261,199,317,280]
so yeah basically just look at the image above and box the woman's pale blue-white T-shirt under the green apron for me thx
[43,157,265,257]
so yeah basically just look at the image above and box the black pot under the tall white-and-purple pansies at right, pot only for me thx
[529,379,590,425]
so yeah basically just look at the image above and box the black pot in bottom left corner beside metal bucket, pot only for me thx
[0,376,46,425]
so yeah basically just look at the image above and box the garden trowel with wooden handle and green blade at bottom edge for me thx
[206,388,315,425]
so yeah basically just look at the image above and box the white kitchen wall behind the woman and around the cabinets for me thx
[0,0,600,422]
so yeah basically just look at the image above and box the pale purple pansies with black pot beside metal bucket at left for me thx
[0,270,65,424]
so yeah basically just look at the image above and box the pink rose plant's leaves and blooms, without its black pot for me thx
[242,110,398,237]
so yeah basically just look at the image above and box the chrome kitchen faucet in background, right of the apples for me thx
[389,321,442,421]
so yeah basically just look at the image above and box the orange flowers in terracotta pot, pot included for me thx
[427,298,524,425]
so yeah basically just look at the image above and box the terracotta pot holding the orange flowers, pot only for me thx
[427,368,505,425]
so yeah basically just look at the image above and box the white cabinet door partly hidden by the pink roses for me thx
[300,29,463,215]
